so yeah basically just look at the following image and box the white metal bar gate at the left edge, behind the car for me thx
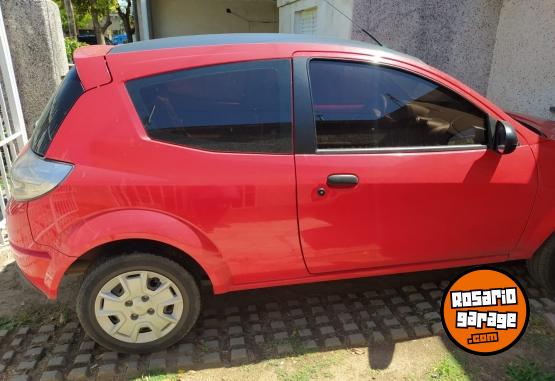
[0,4,27,244]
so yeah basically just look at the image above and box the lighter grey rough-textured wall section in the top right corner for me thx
[487,0,555,120]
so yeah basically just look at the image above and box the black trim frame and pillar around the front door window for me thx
[293,56,494,155]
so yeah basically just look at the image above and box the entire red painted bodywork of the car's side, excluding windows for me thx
[8,43,555,298]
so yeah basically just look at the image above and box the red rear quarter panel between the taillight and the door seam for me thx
[28,56,307,292]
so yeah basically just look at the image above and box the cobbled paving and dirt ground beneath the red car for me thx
[0,252,555,381]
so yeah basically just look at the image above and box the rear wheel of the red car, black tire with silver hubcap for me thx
[76,253,201,353]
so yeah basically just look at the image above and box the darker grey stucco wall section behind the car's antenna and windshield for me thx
[353,0,502,94]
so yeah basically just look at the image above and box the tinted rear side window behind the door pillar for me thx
[127,60,292,153]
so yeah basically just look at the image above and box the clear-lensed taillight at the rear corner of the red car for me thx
[9,149,73,201]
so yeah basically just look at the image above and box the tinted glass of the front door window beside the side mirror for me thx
[310,60,487,149]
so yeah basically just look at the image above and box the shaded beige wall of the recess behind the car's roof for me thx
[150,0,278,38]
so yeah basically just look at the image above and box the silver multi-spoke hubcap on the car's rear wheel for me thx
[94,271,185,343]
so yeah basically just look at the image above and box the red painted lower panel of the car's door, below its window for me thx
[296,146,537,273]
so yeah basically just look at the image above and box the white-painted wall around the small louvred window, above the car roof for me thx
[277,0,354,39]
